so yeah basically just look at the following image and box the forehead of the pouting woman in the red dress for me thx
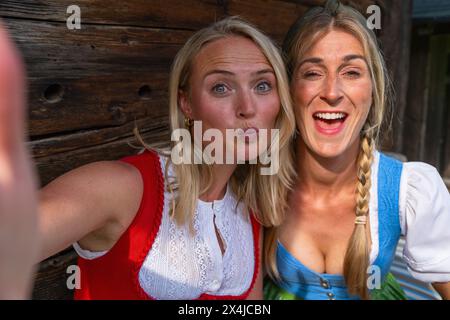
[193,36,272,72]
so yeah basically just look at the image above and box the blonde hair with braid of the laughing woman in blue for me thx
[265,0,392,299]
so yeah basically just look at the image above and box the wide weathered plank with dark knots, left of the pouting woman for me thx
[2,19,191,137]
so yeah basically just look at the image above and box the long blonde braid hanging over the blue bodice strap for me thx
[344,125,374,299]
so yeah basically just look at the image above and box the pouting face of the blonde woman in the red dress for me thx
[179,36,280,160]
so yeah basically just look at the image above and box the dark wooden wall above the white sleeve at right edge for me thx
[403,22,450,182]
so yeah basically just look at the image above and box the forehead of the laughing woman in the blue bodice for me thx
[305,30,364,60]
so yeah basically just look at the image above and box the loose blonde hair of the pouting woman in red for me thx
[140,17,295,231]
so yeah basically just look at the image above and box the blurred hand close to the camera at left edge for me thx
[0,22,39,299]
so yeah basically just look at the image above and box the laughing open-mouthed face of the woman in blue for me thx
[291,30,372,158]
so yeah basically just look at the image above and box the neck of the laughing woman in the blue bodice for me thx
[297,139,359,196]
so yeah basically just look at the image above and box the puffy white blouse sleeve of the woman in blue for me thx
[400,162,450,283]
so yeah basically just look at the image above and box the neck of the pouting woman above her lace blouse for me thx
[200,164,236,202]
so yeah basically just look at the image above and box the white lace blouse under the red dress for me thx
[73,158,255,299]
